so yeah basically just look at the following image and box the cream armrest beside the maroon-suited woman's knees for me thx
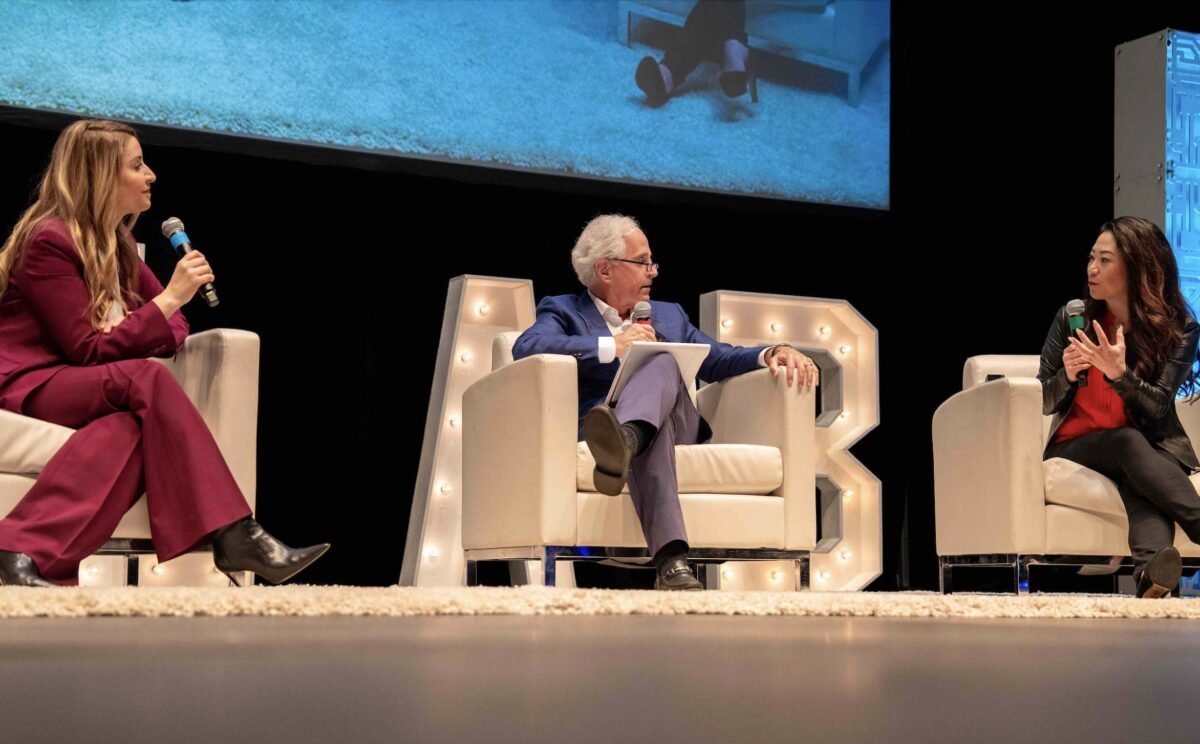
[157,328,258,509]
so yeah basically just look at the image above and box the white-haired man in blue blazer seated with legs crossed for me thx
[512,215,817,589]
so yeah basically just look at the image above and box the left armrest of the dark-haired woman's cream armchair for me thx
[934,377,1046,556]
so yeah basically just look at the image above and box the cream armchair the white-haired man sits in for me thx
[462,332,817,588]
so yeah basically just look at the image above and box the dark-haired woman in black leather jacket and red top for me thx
[1038,217,1200,596]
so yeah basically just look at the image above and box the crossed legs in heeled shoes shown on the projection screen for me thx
[634,0,758,108]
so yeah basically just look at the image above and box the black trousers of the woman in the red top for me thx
[1045,426,1200,575]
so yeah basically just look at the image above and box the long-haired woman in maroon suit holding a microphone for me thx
[0,121,329,587]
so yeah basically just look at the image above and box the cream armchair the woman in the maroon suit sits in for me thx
[0,329,258,581]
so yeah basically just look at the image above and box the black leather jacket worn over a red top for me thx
[1038,306,1200,473]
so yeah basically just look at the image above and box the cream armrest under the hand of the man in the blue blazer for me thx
[696,370,817,550]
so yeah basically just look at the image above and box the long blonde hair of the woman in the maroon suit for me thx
[0,119,140,329]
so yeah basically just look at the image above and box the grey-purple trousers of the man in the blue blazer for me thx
[614,354,708,556]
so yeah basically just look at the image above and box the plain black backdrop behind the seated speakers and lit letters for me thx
[0,0,1200,589]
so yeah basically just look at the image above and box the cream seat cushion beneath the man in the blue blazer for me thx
[575,442,784,496]
